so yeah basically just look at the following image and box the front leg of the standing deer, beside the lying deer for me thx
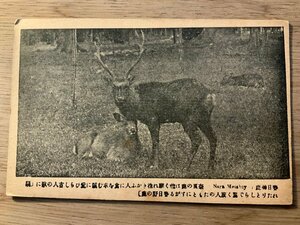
[148,123,160,168]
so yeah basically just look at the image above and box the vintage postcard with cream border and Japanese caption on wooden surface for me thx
[7,19,293,205]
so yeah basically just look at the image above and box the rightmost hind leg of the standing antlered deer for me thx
[198,117,217,169]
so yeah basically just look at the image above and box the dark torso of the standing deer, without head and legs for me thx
[125,78,210,123]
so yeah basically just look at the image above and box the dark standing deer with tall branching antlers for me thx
[95,31,217,168]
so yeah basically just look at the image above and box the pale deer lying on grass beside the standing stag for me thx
[73,113,140,161]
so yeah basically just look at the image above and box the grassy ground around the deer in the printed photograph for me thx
[17,29,288,178]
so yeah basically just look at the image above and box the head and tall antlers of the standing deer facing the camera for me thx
[94,30,145,104]
